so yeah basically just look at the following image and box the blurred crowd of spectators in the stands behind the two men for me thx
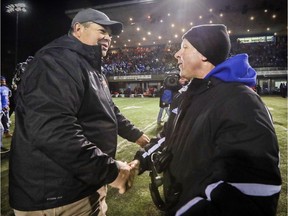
[103,40,287,76]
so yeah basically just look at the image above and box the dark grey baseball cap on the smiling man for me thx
[71,8,123,35]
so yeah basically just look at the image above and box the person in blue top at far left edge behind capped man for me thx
[0,76,12,137]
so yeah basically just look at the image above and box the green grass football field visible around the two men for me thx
[1,96,287,216]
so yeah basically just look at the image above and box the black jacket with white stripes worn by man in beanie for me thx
[164,78,281,216]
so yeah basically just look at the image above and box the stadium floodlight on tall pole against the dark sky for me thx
[6,3,27,67]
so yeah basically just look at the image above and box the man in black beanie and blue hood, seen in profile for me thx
[133,24,281,216]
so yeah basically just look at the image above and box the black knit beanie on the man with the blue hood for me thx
[182,24,231,66]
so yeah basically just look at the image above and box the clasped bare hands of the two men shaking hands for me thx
[109,160,140,194]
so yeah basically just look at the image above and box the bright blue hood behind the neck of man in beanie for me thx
[204,53,256,87]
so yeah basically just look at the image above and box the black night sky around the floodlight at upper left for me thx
[1,0,132,80]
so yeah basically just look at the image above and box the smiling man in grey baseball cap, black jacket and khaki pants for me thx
[9,9,149,216]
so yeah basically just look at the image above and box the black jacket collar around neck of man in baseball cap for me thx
[38,33,102,67]
